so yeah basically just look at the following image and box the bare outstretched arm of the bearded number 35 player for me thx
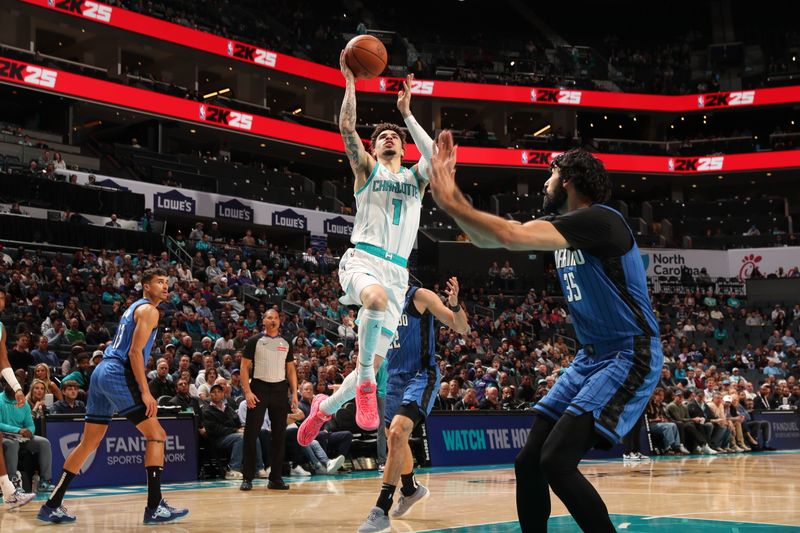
[430,130,569,250]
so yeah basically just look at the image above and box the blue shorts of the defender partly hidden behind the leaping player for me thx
[383,366,441,427]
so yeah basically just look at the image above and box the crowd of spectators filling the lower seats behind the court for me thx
[0,224,800,490]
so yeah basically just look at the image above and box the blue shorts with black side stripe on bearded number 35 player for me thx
[533,337,664,444]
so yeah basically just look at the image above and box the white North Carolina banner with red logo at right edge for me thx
[640,247,800,280]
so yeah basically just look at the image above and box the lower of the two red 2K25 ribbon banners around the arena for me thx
[0,57,800,174]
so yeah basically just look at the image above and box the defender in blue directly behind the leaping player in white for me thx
[358,277,469,533]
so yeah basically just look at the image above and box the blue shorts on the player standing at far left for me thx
[86,360,146,424]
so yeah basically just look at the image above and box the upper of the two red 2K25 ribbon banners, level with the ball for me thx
[21,0,800,112]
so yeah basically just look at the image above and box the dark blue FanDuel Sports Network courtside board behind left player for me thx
[47,417,197,487]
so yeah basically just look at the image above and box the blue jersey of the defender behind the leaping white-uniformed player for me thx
[386,287,436,375]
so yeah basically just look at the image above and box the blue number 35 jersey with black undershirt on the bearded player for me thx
[551,204,659,344]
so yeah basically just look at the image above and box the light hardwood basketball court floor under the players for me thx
[0,451,800,533]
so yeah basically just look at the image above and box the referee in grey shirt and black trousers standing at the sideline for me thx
[240,309,297,490]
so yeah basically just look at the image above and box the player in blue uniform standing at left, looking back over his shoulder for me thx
[37,268,189,524]
